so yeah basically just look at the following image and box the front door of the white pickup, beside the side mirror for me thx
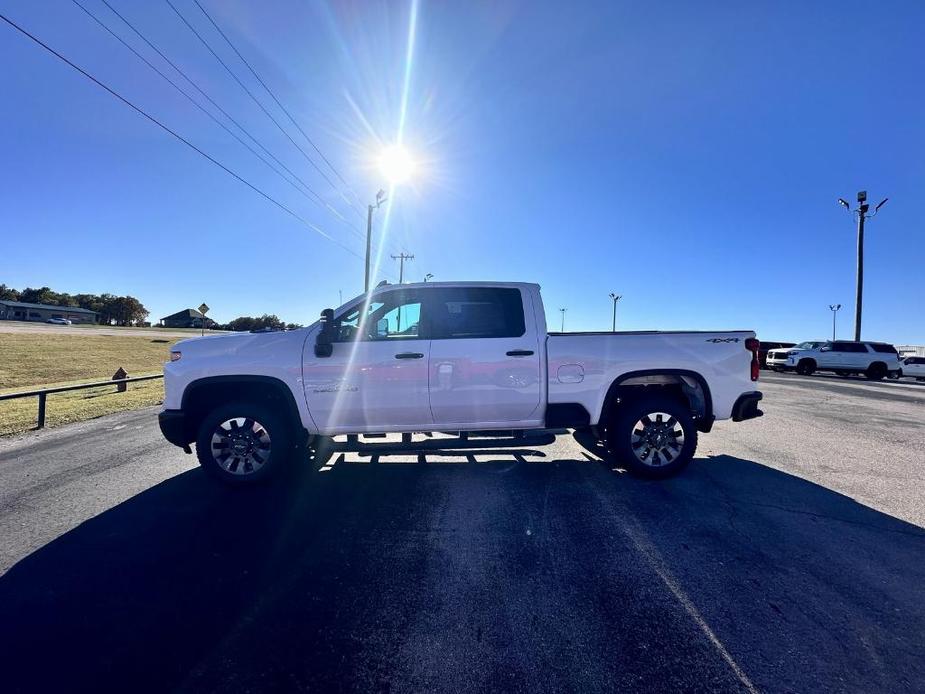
[303,289,433,433]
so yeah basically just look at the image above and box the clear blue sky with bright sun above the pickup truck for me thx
[0,0,925,344]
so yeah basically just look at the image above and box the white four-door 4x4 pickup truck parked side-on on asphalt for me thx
[159,282,762,484]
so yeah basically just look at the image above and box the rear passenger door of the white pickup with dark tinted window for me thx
[427,287,544,430]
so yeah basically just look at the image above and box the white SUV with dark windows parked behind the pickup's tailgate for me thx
[768,340,902,381]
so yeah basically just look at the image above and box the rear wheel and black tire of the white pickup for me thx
[605,395,697,479]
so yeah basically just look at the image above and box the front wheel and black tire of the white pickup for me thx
[196,402,296,486]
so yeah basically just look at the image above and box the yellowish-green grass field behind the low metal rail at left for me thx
[0,333,180,435]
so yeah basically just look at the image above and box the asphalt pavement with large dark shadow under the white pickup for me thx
[0,376,925,692]
